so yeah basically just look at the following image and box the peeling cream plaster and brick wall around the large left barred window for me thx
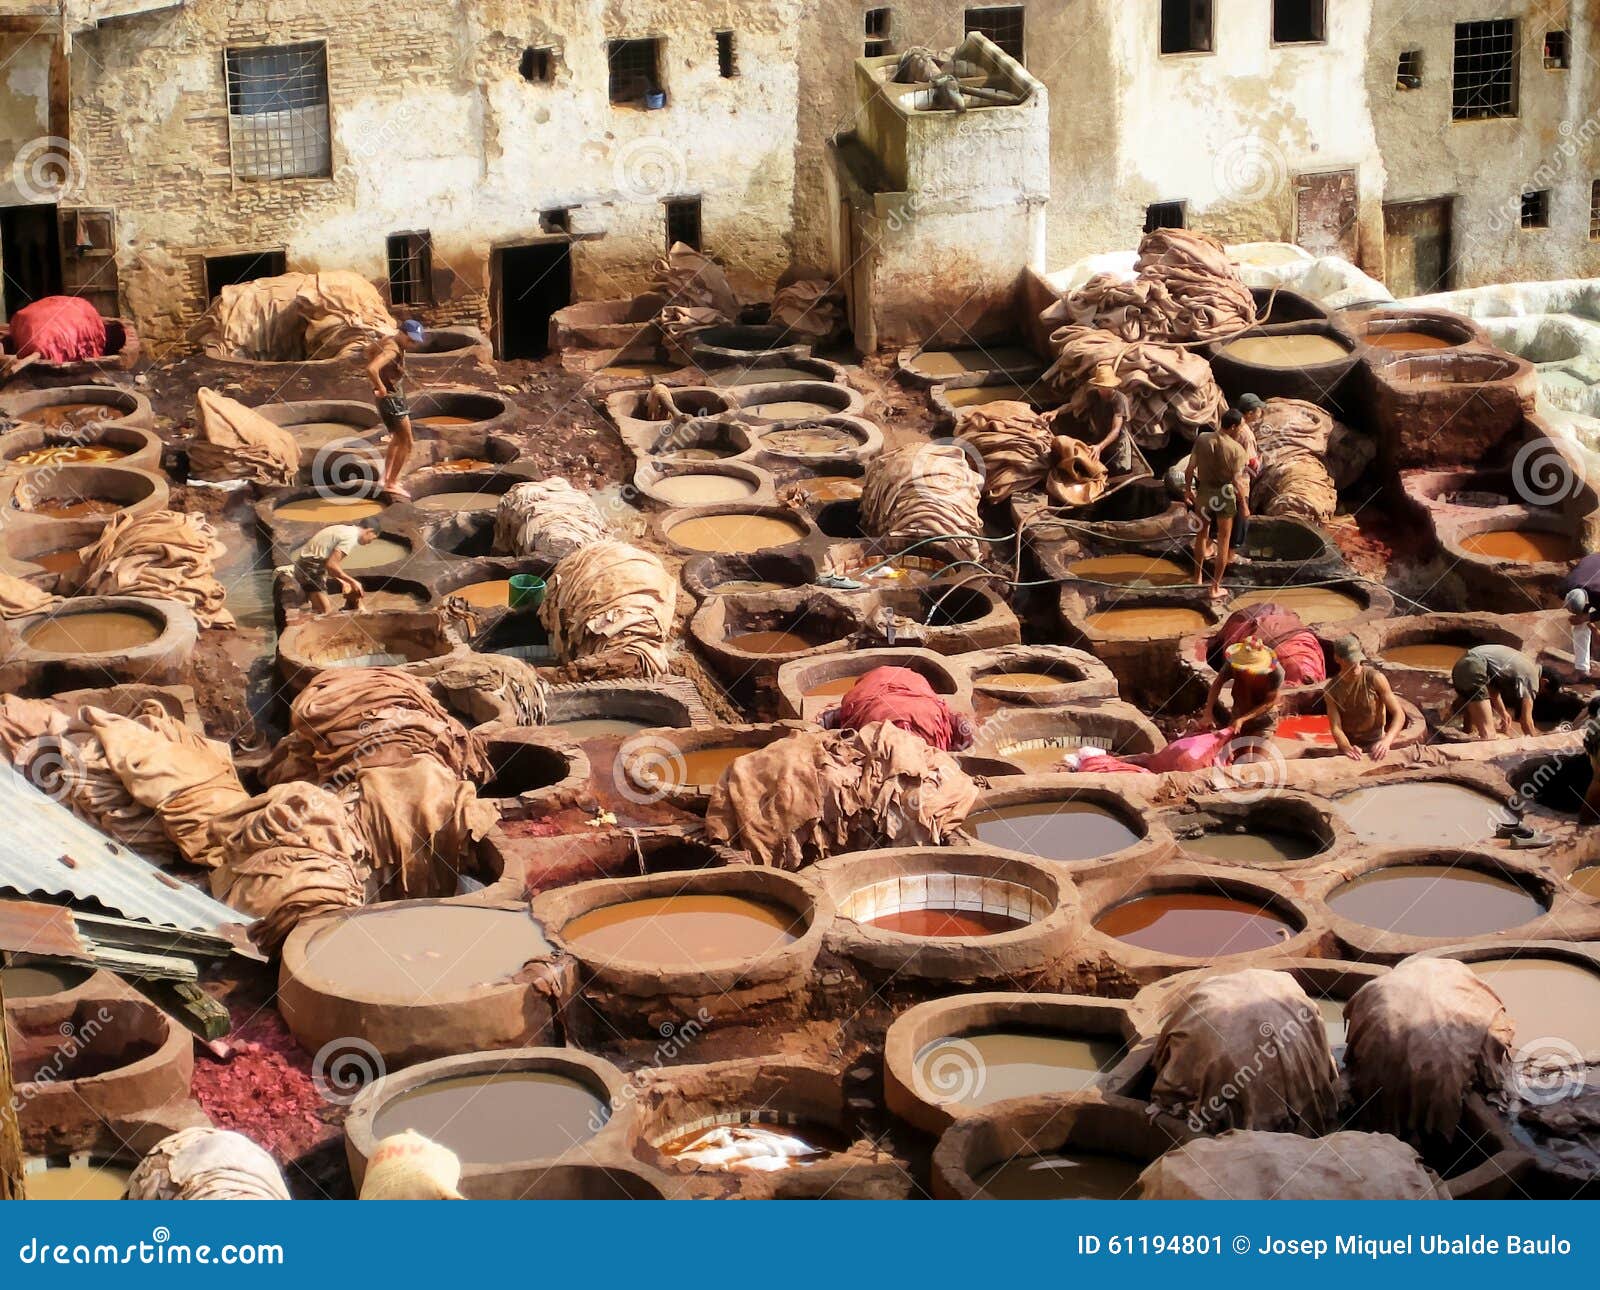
[74,0,797,343]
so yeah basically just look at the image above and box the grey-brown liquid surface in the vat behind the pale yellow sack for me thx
[373,1071,611,1165]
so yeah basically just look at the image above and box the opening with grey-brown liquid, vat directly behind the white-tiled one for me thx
[965,789,1150,864]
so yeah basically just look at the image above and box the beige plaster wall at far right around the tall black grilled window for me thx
[1368,0,1600,286]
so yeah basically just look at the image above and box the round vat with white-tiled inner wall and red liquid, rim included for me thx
[811,847,1078,981]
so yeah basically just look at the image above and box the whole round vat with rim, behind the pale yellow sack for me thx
[344,1048,624,1191]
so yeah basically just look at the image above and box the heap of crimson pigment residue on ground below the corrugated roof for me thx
[192,1005,342,1164]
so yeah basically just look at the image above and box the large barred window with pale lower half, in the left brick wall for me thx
[227,42,333,179]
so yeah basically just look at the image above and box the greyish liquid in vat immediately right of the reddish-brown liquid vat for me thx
[1328,864,1544,938]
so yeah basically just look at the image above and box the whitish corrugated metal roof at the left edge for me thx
[0,763,251,931]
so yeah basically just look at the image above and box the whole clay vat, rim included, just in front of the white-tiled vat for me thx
[883,992,1142,1133]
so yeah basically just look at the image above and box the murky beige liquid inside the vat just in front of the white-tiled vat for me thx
[915,1028,1123,1108]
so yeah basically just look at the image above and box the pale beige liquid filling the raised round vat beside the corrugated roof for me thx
[306,904,552,1004]
